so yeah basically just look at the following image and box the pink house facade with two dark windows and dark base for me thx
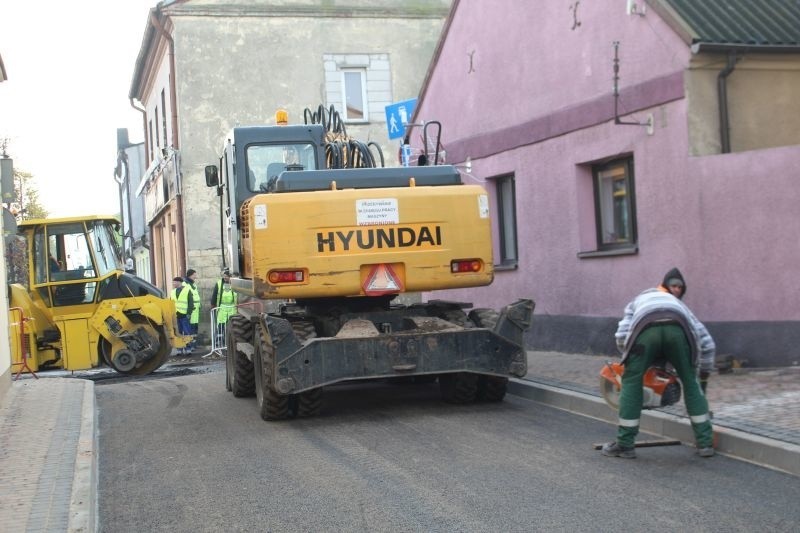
[411,0,800,366]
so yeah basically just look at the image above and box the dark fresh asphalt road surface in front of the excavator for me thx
[95,364,800,533]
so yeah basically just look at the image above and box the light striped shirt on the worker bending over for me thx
[614,289,716,372]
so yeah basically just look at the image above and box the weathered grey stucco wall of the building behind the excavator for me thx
[174,2,447,256]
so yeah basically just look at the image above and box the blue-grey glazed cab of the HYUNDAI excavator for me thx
[205,124,325,272]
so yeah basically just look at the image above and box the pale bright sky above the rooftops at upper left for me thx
[0,0,158,217]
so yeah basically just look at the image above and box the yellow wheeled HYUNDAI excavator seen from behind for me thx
[205,105,534,420]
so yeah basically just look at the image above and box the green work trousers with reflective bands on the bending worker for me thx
[617,323,713,448]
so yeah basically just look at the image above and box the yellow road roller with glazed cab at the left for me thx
[6,216,191,375]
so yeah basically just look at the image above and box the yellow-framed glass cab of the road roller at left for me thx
[19,218,122,308]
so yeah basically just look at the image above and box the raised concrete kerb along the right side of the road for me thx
[508,379,800,476]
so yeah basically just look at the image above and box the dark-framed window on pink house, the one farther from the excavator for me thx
[592,158,636,251]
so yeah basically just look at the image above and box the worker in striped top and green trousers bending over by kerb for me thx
[602,268,716,459]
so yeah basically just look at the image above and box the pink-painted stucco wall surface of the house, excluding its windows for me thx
[417,1,800,362]
